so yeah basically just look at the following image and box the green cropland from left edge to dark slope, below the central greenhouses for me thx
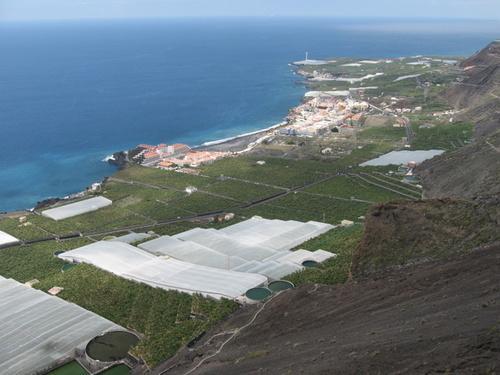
[0,238,237,366]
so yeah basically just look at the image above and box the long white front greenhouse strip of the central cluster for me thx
[59,241,267,299]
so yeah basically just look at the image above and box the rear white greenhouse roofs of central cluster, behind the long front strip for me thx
[139,216,333,279]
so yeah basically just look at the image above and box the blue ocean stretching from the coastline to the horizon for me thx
[0,17,500,211]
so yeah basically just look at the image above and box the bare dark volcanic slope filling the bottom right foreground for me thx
[156,246,500,375]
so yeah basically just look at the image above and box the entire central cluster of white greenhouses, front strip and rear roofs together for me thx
[59,217,335,299]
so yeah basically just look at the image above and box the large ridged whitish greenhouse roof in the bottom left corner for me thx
[0,277,125,374]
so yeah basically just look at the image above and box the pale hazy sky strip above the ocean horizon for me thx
[0,0,500,20]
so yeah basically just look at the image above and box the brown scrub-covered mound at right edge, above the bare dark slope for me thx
[351,195,500,277]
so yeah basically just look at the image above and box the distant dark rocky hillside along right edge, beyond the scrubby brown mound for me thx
[418,41,500,198]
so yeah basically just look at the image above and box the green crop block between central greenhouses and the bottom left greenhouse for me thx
[36,265,237,366]
